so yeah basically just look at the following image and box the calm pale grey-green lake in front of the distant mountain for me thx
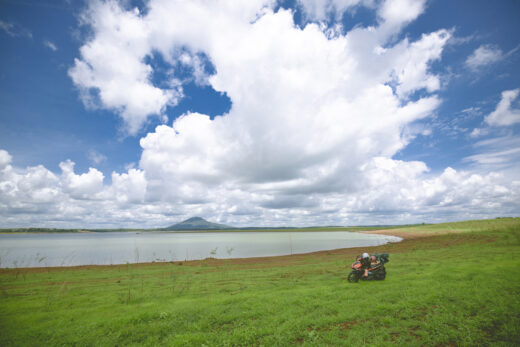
[0,231,401,268]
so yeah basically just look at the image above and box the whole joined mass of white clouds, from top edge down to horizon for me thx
[0,0,520,227]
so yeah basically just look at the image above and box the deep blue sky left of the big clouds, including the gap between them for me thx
[0,1,229,175]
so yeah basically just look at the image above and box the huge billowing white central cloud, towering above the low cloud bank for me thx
[130,0,449,206]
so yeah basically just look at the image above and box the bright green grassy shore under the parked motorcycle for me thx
[0,219,520,346]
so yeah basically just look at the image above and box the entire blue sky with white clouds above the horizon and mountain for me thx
[0,0,520,228]
